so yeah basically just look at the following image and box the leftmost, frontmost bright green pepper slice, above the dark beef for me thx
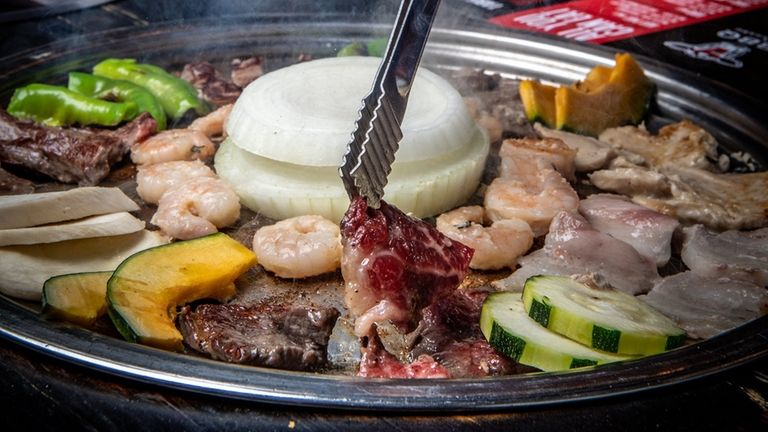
[7,84,137,126]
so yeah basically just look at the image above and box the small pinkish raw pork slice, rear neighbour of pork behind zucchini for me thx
[579,194,680,267]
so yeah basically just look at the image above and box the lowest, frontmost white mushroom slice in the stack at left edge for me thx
[0,230,169,300]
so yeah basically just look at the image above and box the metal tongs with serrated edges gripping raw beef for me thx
[339,0,440,208]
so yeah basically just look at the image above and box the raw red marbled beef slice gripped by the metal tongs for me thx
[341,197,472,336]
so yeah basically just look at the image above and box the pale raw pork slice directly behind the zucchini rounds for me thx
[494,212,659,295]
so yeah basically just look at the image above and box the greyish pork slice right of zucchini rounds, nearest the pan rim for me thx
[640,271,768,339]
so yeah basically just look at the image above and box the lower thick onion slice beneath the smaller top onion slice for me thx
[215,127,489,222]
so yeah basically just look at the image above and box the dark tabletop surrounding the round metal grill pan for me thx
[0,0,768,431]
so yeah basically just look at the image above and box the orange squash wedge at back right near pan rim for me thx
[520,53,654,136]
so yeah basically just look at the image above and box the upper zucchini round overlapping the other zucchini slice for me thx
[523,276,685,355]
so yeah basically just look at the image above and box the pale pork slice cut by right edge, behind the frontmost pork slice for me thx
[681,225,768,286]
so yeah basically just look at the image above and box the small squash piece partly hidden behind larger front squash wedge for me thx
[43,271,112,325]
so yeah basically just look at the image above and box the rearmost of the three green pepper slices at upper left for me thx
[93,58,208,119]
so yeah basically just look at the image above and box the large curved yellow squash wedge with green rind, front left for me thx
[107,233,256,350]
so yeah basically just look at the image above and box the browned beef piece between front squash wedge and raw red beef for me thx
[179,303,339,370]
